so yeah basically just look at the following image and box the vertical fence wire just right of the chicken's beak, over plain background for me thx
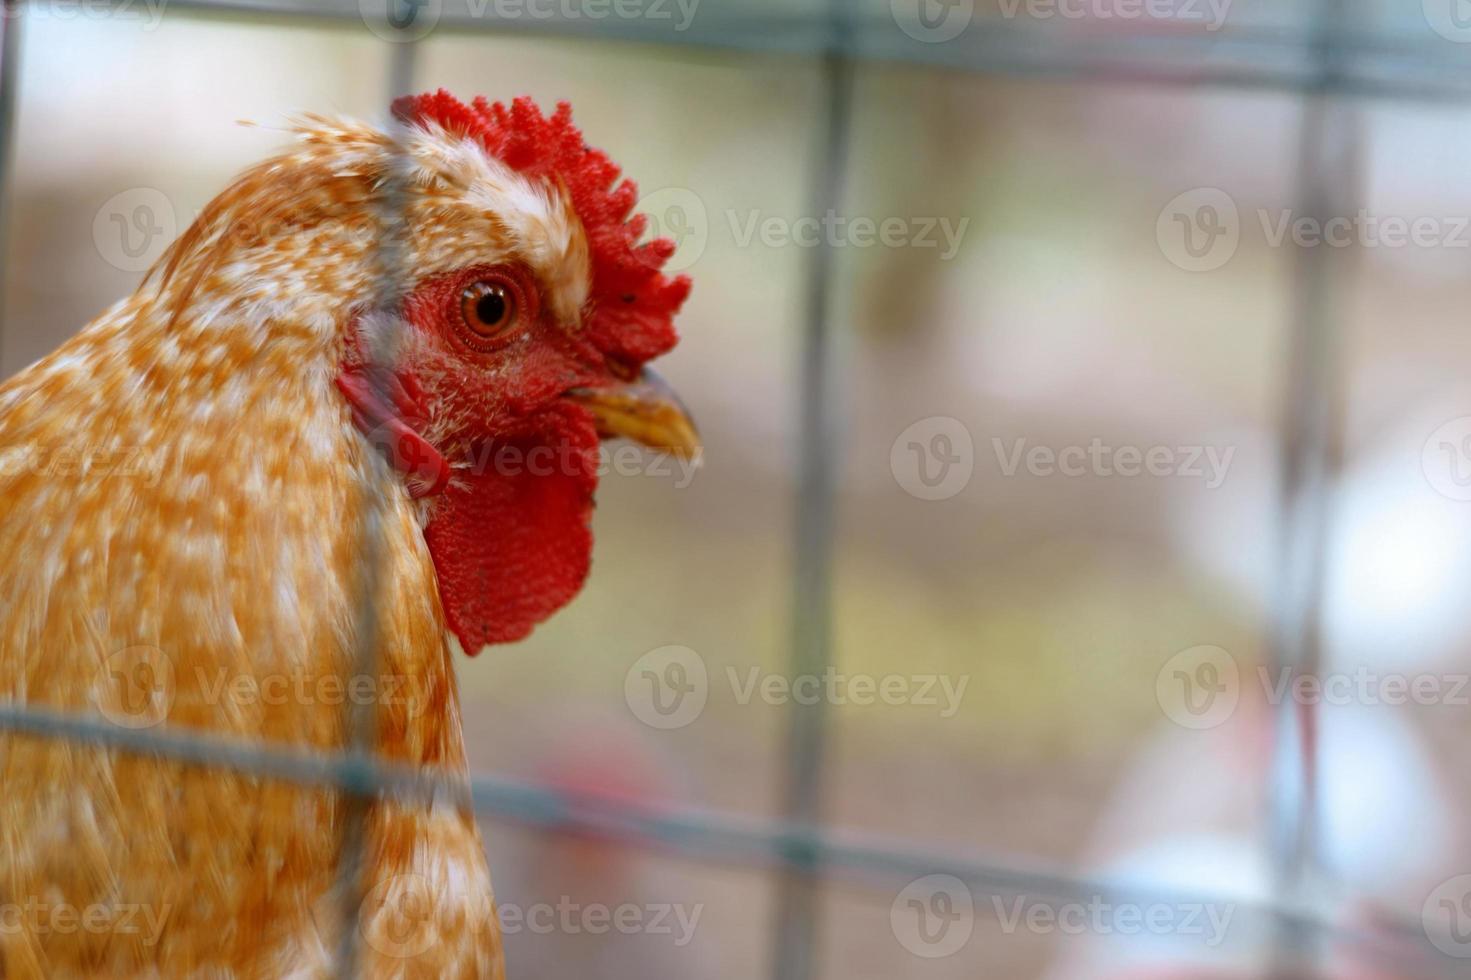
[772,7,853,980]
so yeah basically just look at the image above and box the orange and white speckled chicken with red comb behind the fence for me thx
[0,91,697,980]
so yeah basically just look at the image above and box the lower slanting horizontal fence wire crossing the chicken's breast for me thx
[0,705,1455,977]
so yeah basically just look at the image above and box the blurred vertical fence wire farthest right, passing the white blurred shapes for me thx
[1268,0,1361,976]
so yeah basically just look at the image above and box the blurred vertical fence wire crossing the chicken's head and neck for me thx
[337,30,418,980]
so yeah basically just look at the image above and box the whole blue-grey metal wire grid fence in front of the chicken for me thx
[0,0,1471,980]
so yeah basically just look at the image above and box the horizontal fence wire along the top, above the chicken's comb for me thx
[37,0,1471,100]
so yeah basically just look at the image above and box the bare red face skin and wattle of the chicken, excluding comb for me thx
[338,266,637,655]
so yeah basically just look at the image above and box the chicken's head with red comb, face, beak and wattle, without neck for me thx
[355,91,699,655]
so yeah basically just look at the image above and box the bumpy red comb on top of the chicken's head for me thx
[393,88,690,363]
